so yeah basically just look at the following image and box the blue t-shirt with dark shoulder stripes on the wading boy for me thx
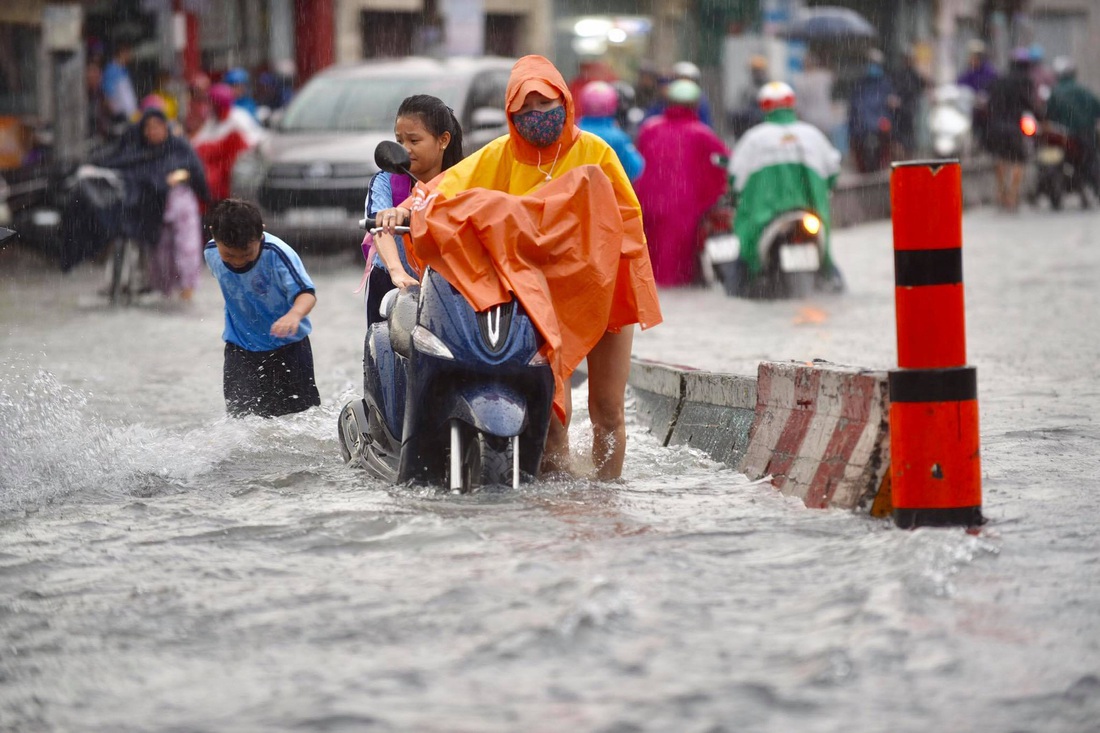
[202,232,316,351]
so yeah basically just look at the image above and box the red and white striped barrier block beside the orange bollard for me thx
[740,361,890,508]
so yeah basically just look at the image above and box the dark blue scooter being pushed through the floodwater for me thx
[338,141,553,493]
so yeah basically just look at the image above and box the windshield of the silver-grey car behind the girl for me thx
[279,75,465,132]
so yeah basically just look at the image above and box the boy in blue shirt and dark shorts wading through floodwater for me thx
[204,198,321,417]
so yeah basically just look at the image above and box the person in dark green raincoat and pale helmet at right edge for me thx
[1046,56,1100,206]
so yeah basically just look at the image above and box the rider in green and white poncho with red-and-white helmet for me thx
[729,81,840,282]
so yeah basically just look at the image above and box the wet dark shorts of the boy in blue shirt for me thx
[223,337,321,417]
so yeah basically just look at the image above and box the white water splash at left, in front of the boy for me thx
[0,364,329,514]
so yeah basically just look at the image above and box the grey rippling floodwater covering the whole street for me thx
[0,206,1100,733]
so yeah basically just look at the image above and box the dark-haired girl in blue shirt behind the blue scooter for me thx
[363,95,462,326]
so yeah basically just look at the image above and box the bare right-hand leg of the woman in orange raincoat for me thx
[589,326,634,481]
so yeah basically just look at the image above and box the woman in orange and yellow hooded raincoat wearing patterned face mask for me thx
[377,56,661,480]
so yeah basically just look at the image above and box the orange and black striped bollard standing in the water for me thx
[889,160,983,528]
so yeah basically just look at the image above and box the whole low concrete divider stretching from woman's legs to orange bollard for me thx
[630,360,890,511]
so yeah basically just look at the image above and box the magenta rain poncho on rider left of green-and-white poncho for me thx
[634,106,729,286]
